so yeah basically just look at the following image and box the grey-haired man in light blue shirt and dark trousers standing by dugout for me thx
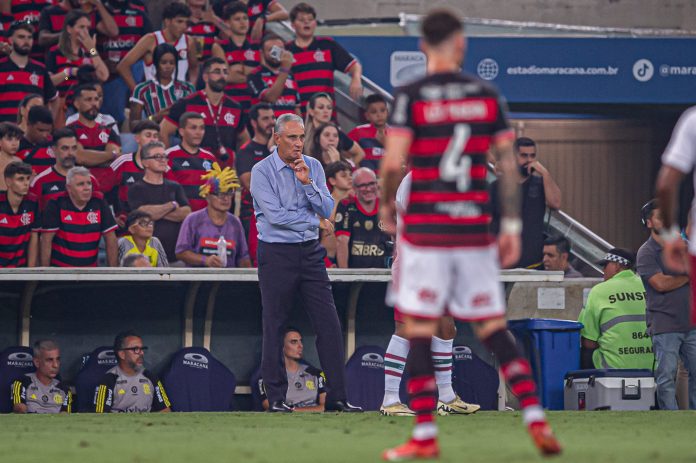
[251,114,362,412]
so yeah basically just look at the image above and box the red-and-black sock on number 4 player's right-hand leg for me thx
[483,330,546,425]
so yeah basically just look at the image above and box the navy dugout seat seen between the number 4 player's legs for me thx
[452,346,500,410]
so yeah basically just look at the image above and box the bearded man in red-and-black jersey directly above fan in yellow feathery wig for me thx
[160,57,249,167]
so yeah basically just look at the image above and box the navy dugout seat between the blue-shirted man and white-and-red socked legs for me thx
[346,346,385,410]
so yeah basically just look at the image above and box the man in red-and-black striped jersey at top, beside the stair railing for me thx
[287,3,362,111]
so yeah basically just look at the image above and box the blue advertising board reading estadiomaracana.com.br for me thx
[336,37,696,105]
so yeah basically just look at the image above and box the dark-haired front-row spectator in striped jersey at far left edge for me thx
[0,162,41,268]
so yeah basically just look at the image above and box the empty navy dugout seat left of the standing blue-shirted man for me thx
[162,347,237,412]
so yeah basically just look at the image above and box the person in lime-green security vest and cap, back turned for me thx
[578,248,655,370]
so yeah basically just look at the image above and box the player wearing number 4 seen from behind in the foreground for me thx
[381,10,561,461]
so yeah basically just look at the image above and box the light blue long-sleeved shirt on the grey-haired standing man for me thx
[251,148,334,243]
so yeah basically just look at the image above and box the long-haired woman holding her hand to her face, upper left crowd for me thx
[46,11,109,125]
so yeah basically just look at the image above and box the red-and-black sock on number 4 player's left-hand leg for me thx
[406,338,437,445]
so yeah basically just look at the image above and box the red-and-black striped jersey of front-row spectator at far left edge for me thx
[0,191,41,268]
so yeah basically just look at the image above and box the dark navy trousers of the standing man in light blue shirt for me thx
[258,240,346,404]
